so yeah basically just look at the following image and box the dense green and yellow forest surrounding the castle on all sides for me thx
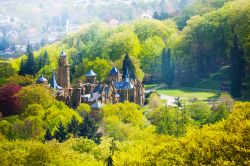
[0,0,250,165]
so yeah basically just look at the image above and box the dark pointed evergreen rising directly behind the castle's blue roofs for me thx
[122,53,136,79]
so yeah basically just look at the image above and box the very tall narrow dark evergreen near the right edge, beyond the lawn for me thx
[231,32,245,98]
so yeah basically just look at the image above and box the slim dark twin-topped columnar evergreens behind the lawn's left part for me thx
[161,49,174,88]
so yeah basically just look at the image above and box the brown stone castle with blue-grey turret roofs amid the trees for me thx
[37,52,145,109]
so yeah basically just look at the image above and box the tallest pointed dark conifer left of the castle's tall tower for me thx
[25,44,35,75]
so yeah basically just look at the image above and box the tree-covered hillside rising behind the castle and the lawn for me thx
[2,0,250,97]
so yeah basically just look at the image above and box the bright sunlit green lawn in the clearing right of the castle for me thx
[156,87,220,100]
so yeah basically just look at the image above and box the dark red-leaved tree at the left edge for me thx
[0,84,21,116]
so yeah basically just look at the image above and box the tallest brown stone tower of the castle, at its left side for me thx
[58,51,70,89]
